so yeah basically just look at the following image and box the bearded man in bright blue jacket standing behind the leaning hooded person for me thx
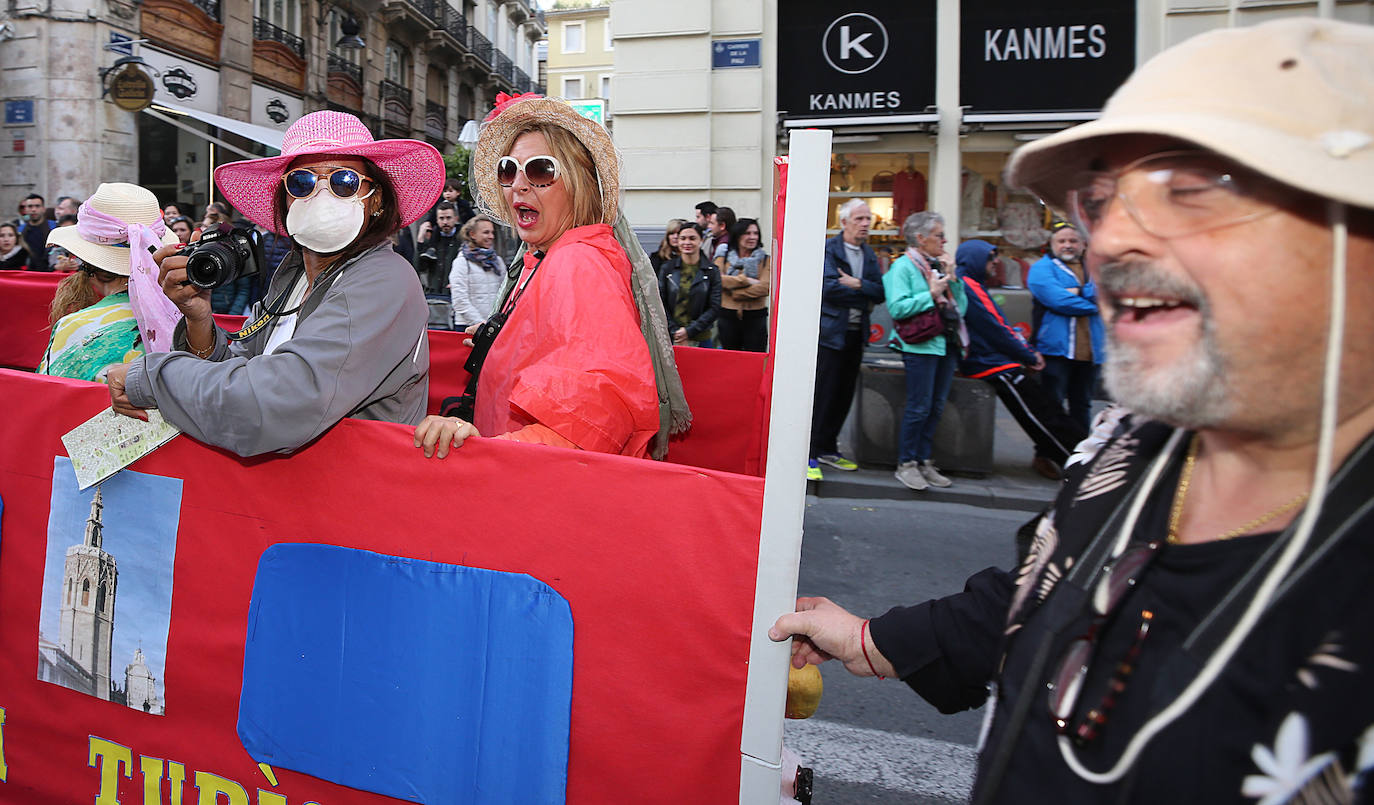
[1026,223,1105,430]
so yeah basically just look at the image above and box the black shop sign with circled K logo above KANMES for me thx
[778,0,936,118]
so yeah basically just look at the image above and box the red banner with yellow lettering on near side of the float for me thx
[0,370,763,805]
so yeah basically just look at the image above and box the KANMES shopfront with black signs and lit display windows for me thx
[776,0,1374,278]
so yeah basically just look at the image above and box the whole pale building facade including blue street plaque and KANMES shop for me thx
[610,0,1374,250]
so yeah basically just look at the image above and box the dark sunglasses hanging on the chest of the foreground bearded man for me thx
[1048,543,1160,746]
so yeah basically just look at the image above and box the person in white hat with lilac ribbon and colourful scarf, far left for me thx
[38,183,177,382]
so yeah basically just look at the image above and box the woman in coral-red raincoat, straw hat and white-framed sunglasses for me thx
[415,93,690,457]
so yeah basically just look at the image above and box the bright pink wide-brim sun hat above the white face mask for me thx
[214,111,445,235]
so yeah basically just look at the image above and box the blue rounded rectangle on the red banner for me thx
[238,544,573,805]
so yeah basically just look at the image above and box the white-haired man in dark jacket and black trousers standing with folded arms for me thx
[807,199,882,481]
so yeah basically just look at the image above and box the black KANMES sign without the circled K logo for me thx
[959,0,1135,113]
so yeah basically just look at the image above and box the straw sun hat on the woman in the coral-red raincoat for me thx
[473,92,620,225]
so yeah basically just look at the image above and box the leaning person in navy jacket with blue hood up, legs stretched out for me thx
[954,240,1088,481]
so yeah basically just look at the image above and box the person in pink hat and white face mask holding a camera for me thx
[110,111,444,456]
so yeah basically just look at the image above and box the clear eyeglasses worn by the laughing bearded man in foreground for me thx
[1065,151,1276,238]
